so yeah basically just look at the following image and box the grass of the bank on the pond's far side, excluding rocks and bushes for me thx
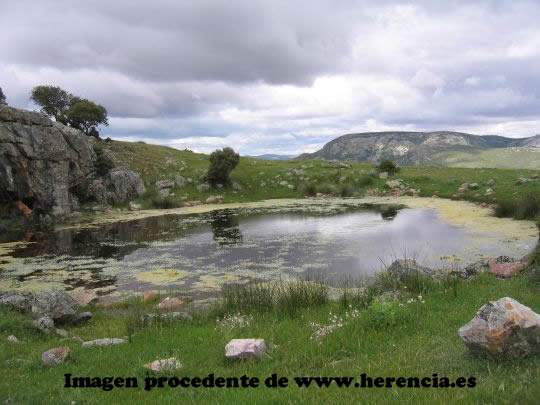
[103,141,540,208]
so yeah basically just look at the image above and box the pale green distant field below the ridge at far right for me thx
[436,148,540,170]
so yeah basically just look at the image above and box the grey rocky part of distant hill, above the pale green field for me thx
[298,131,540,167]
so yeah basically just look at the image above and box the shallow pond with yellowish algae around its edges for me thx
[0,198,538,298]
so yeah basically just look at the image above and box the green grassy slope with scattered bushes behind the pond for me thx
[95,141,540,215]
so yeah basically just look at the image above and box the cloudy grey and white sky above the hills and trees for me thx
[0,0,540,155]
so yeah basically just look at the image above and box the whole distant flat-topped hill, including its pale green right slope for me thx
[298,131,540,169]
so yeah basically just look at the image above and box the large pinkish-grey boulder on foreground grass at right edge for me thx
[458,297,540,357]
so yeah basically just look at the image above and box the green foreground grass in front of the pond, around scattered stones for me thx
[0,274,540,404]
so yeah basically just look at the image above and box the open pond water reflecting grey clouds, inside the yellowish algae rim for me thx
[5,208,534,295]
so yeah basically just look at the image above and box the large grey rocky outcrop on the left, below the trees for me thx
[0,105,144,216]
